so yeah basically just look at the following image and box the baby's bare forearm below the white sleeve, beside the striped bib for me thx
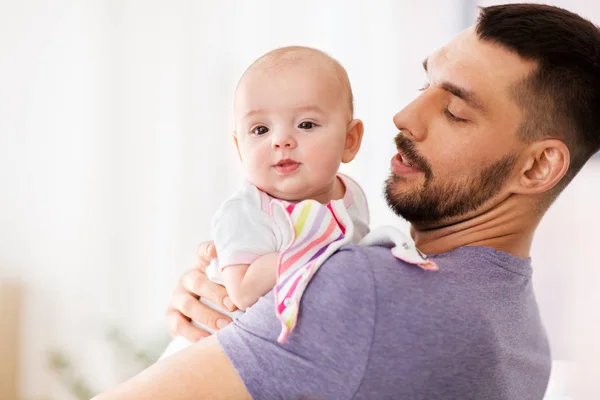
[222,253,279,311]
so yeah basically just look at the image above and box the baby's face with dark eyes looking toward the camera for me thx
[234,63,351,201]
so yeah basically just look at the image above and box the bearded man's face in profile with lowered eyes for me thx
[385,28,535,228]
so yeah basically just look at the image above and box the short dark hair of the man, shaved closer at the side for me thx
[475,4,600,194]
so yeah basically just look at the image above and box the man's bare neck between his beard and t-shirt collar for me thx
[411,196,541,257]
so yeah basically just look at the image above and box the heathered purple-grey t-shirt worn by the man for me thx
[217,245,550,400]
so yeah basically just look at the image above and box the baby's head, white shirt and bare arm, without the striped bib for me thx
[213,47,369,310]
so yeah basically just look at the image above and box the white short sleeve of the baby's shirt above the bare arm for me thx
[211,189,277,270]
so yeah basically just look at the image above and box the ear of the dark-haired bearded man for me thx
[514,139,571,194]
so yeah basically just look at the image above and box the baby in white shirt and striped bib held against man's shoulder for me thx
[163,47,432,357]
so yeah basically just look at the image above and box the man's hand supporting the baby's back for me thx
[166,242,237,342]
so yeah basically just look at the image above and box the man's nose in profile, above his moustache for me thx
[394,92,435,142]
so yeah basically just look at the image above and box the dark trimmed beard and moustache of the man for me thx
[384,134,517,226]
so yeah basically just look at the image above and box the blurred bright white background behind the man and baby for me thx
[0,0,600,400]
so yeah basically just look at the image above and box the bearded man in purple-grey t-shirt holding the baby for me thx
[100,4,600,400]
